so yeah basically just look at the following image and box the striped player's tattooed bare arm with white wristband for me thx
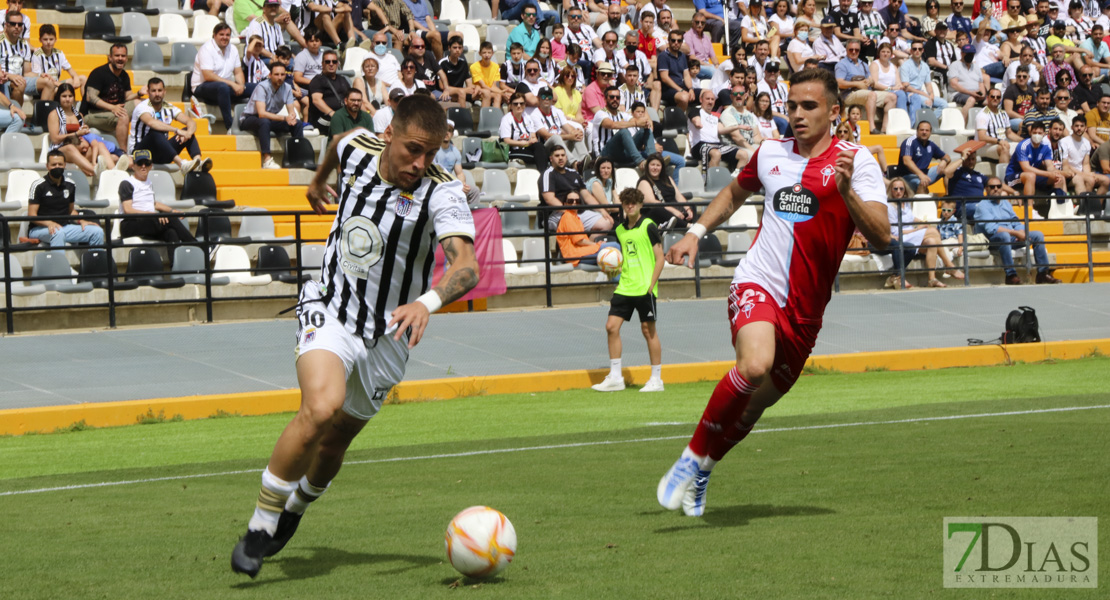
[386,236,478,348]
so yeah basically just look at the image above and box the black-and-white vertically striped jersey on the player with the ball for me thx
[321,129,474,339]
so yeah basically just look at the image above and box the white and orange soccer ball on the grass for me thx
[446,506,516,578]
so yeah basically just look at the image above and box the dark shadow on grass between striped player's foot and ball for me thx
[232,547,443,589]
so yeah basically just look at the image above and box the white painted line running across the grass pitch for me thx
[0,404,1110,497]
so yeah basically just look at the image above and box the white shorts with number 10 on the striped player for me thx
[295,282,408,420]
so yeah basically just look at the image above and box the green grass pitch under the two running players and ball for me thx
[0,358,1110,600]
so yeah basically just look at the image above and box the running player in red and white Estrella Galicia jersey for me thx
[657,69,890,517]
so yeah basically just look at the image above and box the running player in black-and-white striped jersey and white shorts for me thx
[231,94,478,578]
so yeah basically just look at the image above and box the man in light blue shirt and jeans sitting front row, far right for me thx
[975,180,1060,285]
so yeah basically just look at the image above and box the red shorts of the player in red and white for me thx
[728,283,820,394]
